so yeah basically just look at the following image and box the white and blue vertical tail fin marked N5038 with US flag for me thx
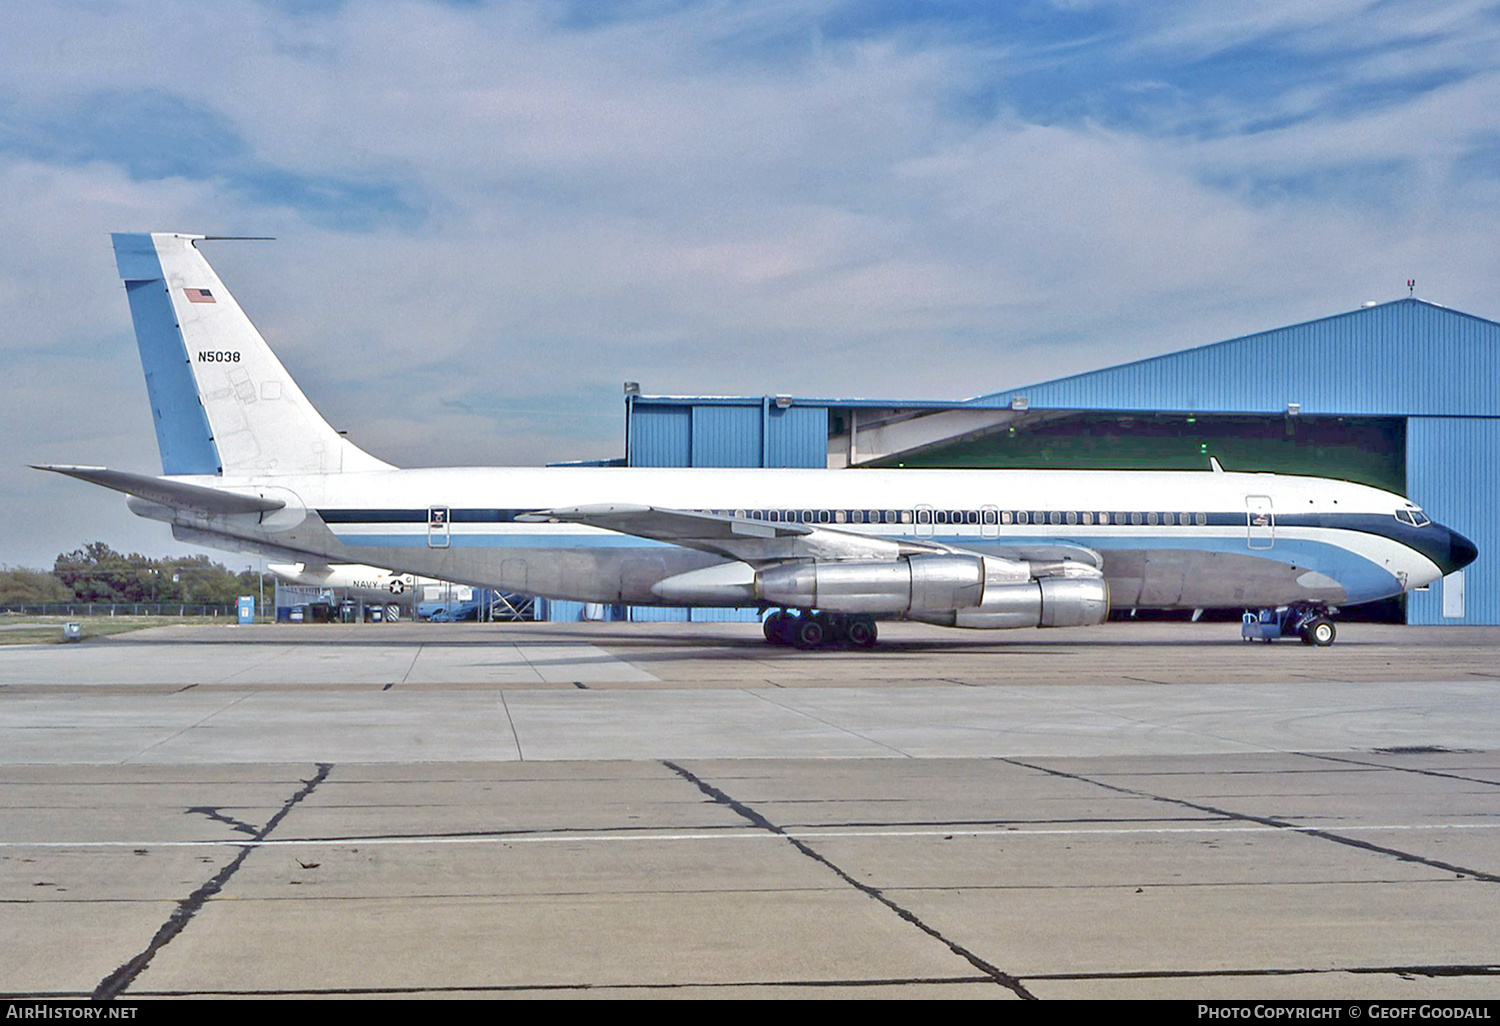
[113,233,390,476]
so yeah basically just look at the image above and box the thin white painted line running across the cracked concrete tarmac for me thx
[0,824,1500,849]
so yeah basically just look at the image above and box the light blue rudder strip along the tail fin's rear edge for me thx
[114,234,224,474]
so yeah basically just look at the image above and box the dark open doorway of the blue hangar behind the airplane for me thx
[867,411,1410,624]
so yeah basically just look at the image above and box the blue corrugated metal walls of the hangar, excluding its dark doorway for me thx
[629,299,1500,624]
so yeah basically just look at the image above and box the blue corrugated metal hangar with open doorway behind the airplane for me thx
[615,299,1500,624]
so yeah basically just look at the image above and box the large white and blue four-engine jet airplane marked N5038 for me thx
[38,233,1478,650]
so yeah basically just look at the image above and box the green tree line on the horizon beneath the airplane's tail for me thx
[0,542,260,605]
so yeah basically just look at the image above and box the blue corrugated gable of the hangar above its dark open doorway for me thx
[972,299,1500,417]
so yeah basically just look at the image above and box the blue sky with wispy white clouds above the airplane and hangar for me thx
[0,0,1500,569]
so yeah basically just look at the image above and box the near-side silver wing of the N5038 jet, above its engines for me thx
[516,506,948,566]
